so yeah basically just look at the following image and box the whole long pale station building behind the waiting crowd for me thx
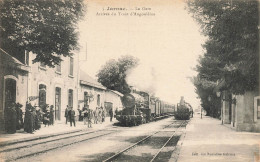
[0,49,123,131]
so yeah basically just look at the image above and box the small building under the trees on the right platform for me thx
[216,81,260,132]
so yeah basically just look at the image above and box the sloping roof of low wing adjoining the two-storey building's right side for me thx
[80,70,107,90]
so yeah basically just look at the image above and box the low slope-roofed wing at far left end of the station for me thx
[0,49,30,131]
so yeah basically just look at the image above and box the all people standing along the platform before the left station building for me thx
[5,102,117,133]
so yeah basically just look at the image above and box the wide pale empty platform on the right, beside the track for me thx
[172,115,260,162]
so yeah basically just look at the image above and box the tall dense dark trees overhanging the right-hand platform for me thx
[188,0,259,116]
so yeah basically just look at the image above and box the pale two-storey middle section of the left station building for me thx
[26,52,78,120]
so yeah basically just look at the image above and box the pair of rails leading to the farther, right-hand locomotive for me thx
[103,121,187,162]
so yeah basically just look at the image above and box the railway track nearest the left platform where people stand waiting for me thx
[0,128,120,161]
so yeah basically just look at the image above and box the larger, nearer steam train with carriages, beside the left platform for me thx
[116,90,175,126]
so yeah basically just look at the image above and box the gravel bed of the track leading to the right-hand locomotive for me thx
[107,121,188,162]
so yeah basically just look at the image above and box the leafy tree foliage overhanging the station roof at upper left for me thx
[0,0,84,67]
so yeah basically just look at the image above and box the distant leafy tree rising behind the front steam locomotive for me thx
[97,55,139,94]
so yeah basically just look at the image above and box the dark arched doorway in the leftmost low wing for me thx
[5,78,16,108]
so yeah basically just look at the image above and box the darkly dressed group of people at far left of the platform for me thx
[5,102,54,134]
